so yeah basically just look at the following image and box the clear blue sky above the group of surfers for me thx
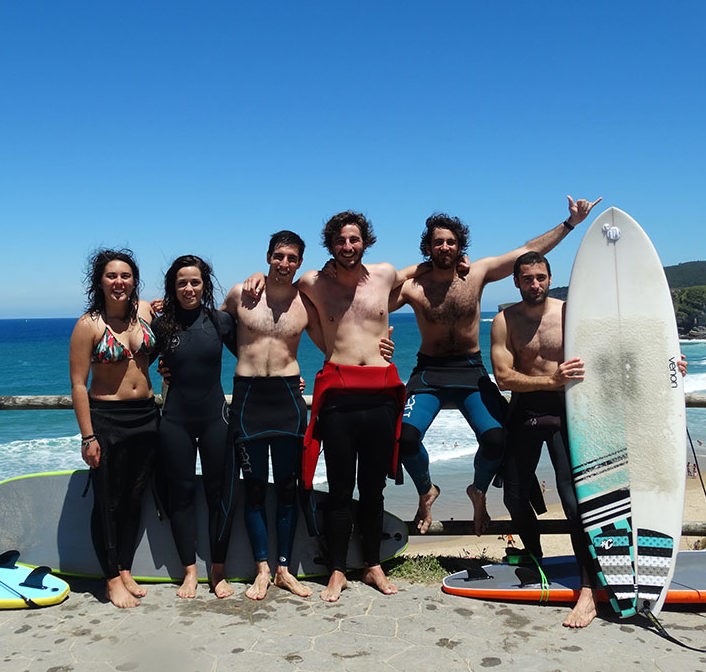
[0,0,706,317]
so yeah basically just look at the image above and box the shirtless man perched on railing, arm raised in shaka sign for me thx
[390,196,601,535]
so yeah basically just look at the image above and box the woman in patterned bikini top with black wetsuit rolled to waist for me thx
[69,249,159,608]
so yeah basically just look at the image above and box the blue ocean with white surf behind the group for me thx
[0,313,706,518]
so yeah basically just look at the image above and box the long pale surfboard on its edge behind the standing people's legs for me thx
[0,470,407,581]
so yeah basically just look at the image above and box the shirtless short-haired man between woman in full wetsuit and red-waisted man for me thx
[223,231,319,600]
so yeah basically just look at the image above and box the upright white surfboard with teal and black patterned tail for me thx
[564,208,686,616]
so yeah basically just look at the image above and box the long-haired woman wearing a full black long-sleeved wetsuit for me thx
[152,254,237,598]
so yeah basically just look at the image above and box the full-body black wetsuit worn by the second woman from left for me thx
[155,308,236,566]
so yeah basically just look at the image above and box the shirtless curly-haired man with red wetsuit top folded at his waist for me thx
[299,211,404,602]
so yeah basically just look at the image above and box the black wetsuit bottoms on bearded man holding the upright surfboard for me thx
[503,392,595,586]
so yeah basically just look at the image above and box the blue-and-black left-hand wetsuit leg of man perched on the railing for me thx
[400,393,441,495]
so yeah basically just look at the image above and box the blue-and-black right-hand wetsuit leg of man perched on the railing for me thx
[457,389,505,492]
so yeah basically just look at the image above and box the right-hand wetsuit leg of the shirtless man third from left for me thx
[270,437,303,567]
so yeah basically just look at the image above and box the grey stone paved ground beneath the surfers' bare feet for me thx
[0,580,706,672]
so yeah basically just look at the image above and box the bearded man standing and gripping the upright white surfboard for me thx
[491,252,596,628]
